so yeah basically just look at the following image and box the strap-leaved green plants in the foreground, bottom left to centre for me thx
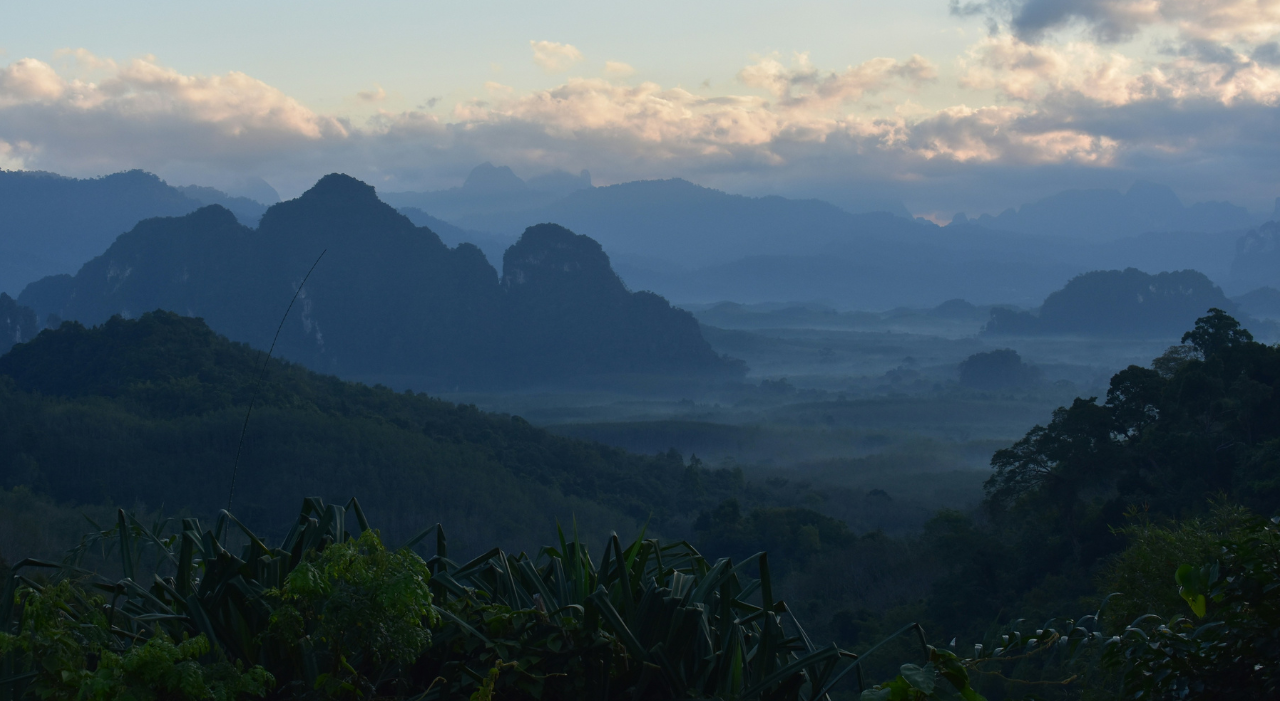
[0,499,885,701]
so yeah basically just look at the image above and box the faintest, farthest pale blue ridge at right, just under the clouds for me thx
[955,182,1257,239]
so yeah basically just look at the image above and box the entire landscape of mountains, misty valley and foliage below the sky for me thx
[0,164,1280,701]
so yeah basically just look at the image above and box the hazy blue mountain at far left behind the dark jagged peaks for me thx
[0,170,262,294]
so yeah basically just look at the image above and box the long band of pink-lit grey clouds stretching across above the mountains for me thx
[0,43,1280,211]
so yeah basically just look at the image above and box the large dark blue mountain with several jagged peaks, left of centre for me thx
[19,175,741,389]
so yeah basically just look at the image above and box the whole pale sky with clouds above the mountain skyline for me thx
[0,0,1280,221]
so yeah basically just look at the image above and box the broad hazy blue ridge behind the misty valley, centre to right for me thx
[407,179,1243,310]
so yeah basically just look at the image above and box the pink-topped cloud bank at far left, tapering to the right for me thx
[0,54,347,180]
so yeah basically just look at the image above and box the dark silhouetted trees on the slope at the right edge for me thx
[927,308,1280,638]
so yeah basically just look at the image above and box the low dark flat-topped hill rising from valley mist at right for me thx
[983,267,1235,339]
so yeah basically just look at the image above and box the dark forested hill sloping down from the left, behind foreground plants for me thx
[0,312,744,547]
